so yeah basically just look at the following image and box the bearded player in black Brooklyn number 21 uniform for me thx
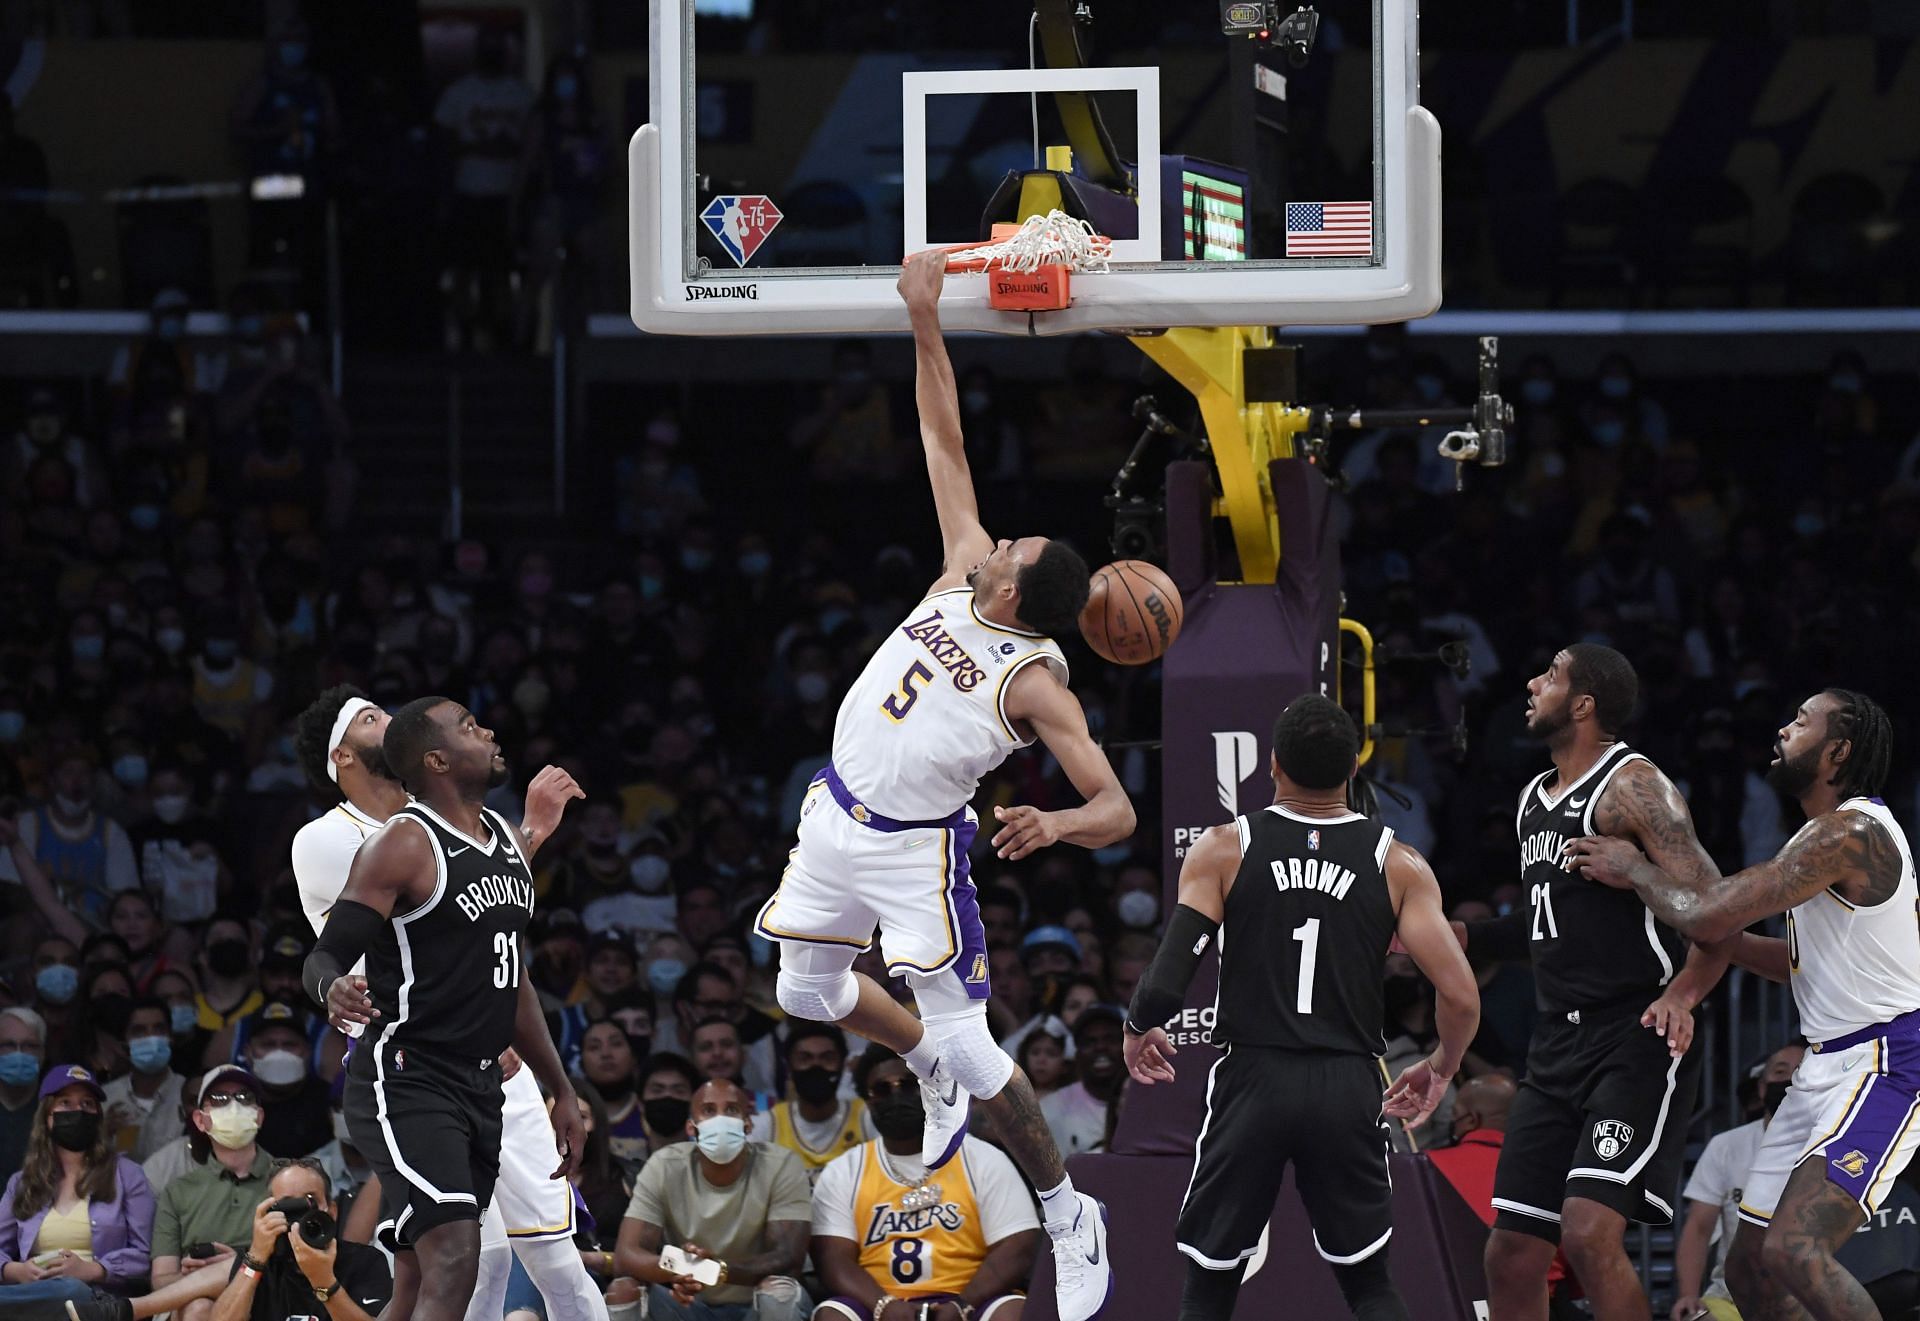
[1455,643,1726,1321]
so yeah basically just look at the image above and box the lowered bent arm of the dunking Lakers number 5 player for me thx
[993,664,1135,858]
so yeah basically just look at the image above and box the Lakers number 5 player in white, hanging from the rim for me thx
[755,252,1133,1321]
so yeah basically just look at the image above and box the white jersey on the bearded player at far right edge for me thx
[1788,799,1920,1041]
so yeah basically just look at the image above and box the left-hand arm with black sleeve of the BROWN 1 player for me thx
[1121,824,1240,1087]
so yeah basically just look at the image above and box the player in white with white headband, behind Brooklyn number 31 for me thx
[294,684,607,1321]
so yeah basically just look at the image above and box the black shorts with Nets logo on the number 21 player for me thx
[1494,997,1701,1242]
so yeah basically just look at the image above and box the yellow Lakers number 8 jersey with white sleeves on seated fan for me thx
[814,1137,1041,1298]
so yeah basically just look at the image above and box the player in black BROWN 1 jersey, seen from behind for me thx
[1125,695,1480,1321]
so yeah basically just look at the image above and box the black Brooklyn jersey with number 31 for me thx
[367,801,534,1060]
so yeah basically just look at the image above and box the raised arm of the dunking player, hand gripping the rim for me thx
[900,250,993,588]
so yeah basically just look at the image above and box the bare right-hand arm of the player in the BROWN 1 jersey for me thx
[1386,841,1480,1123]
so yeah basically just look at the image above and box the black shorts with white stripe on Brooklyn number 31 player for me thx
[342,1043,501,1248]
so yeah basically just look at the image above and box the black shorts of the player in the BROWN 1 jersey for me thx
[1175,1046,1394,1271]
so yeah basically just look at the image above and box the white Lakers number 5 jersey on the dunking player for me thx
[833,588,1068,822]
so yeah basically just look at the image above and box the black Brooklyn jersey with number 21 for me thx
[1515,743,1686,1014]
